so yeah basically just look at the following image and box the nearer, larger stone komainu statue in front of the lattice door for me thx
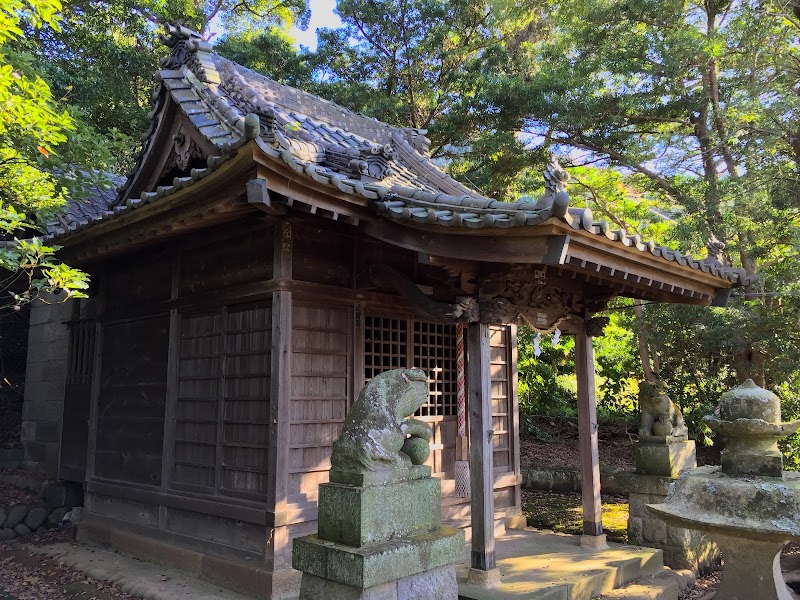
[331,369,432,472]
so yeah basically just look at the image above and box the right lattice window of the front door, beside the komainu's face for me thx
[414,321,458,417]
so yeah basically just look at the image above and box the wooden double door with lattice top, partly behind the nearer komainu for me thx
[364,315,458,495]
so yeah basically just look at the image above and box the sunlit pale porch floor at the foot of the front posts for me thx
[456,529,663,600]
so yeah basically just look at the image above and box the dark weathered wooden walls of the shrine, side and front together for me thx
[75,213,519,568]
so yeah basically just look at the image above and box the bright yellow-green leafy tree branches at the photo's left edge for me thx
[0,0,99,310]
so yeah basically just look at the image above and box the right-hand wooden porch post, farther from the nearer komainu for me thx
[575,331,605,548]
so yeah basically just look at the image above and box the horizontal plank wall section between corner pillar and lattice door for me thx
[287,301,352,502]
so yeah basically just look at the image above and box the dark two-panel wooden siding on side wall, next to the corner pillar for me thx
[173,302,271,501]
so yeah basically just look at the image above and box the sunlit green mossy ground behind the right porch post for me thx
[522,492,628,544]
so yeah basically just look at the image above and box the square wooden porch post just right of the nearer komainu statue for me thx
[467,323,499,587]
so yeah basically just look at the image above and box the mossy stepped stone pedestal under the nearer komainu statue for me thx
[292,467,464,600]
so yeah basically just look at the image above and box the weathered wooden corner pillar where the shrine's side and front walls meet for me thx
[264,223,292,570]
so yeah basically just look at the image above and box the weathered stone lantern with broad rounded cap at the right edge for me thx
[648,379,800,600]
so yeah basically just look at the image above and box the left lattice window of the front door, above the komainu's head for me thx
[364,316,408,381]
